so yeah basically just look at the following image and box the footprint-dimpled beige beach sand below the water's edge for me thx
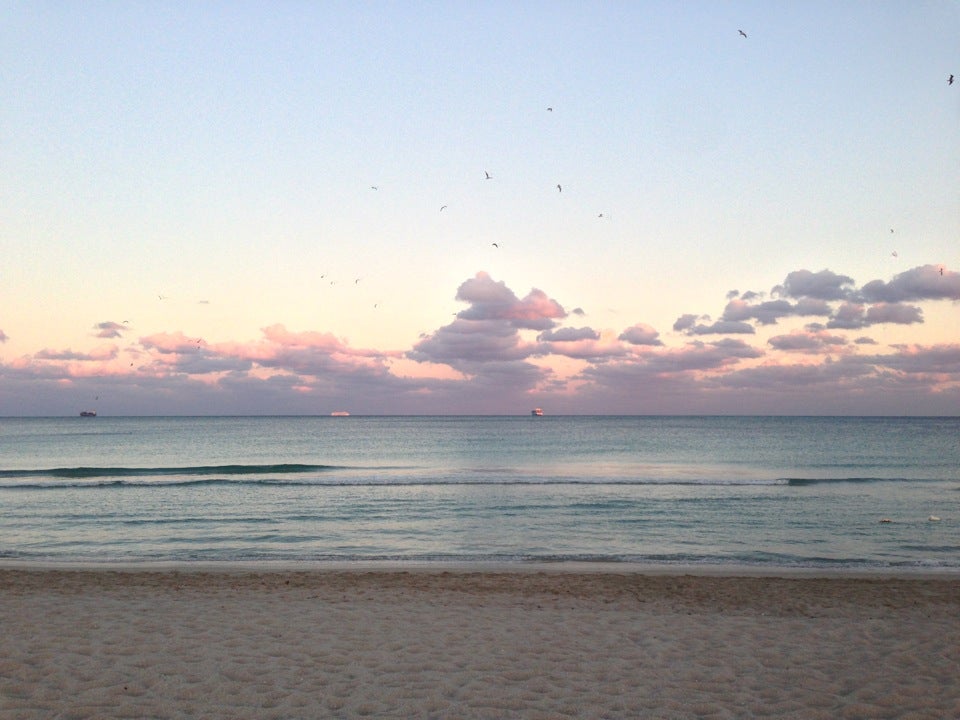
[0,568,960,720]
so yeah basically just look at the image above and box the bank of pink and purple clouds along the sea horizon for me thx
[0,265,960,415]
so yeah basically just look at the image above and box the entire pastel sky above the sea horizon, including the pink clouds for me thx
[0,0,960,416]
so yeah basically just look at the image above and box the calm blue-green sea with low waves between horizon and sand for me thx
[0,416,960,570]
